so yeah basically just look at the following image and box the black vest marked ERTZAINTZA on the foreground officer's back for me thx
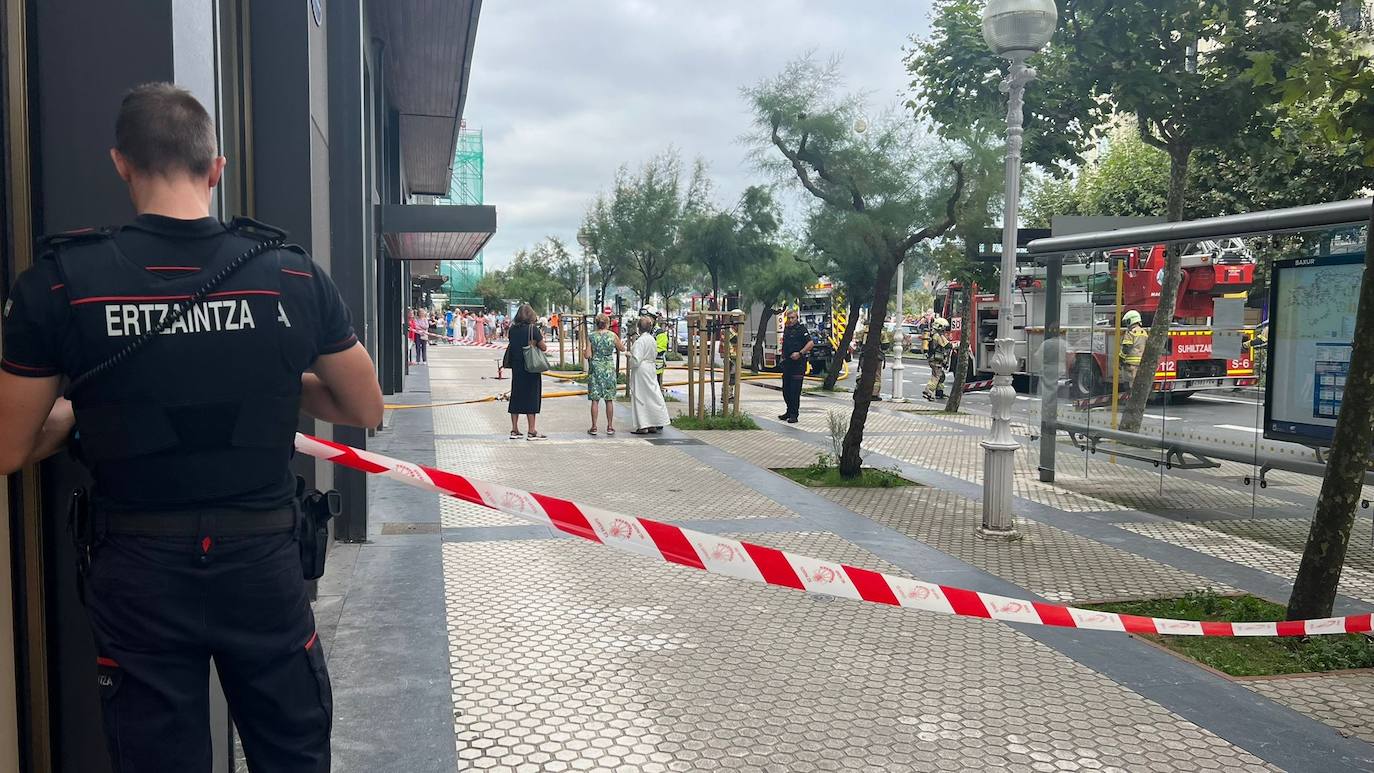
[52,221,313,511]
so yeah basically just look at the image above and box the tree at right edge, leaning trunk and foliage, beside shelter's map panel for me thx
[1246,1,1374,619]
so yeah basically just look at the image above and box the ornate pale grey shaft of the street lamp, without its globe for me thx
[978,51,1035,540]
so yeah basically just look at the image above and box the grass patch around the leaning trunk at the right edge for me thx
[1087,593,1374,677]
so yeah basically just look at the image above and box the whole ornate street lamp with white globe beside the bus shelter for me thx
[978,0,1059,540]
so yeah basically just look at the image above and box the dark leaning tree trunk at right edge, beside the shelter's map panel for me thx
[1287,203,1374,621]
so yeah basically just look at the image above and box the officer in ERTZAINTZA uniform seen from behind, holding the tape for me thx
[0,84,382,773]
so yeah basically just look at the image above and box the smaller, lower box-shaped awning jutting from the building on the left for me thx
[381,205,496,262]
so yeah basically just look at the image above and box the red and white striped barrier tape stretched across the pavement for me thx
[295,434,1371,636]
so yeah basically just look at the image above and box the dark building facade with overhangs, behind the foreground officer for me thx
[0,0,496,773]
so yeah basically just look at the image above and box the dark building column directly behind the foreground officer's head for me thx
[26,0,229,773]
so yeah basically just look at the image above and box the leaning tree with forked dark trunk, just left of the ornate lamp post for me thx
[745,59,963,478]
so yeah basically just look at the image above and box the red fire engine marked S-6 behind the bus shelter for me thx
[943,239,1256,400]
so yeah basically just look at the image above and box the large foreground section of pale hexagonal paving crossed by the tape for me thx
[444,534,1272,773]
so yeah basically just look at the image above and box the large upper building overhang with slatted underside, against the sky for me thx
[368,0,482,196]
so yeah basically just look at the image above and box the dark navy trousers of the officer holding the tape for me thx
[87,533,333,773]
